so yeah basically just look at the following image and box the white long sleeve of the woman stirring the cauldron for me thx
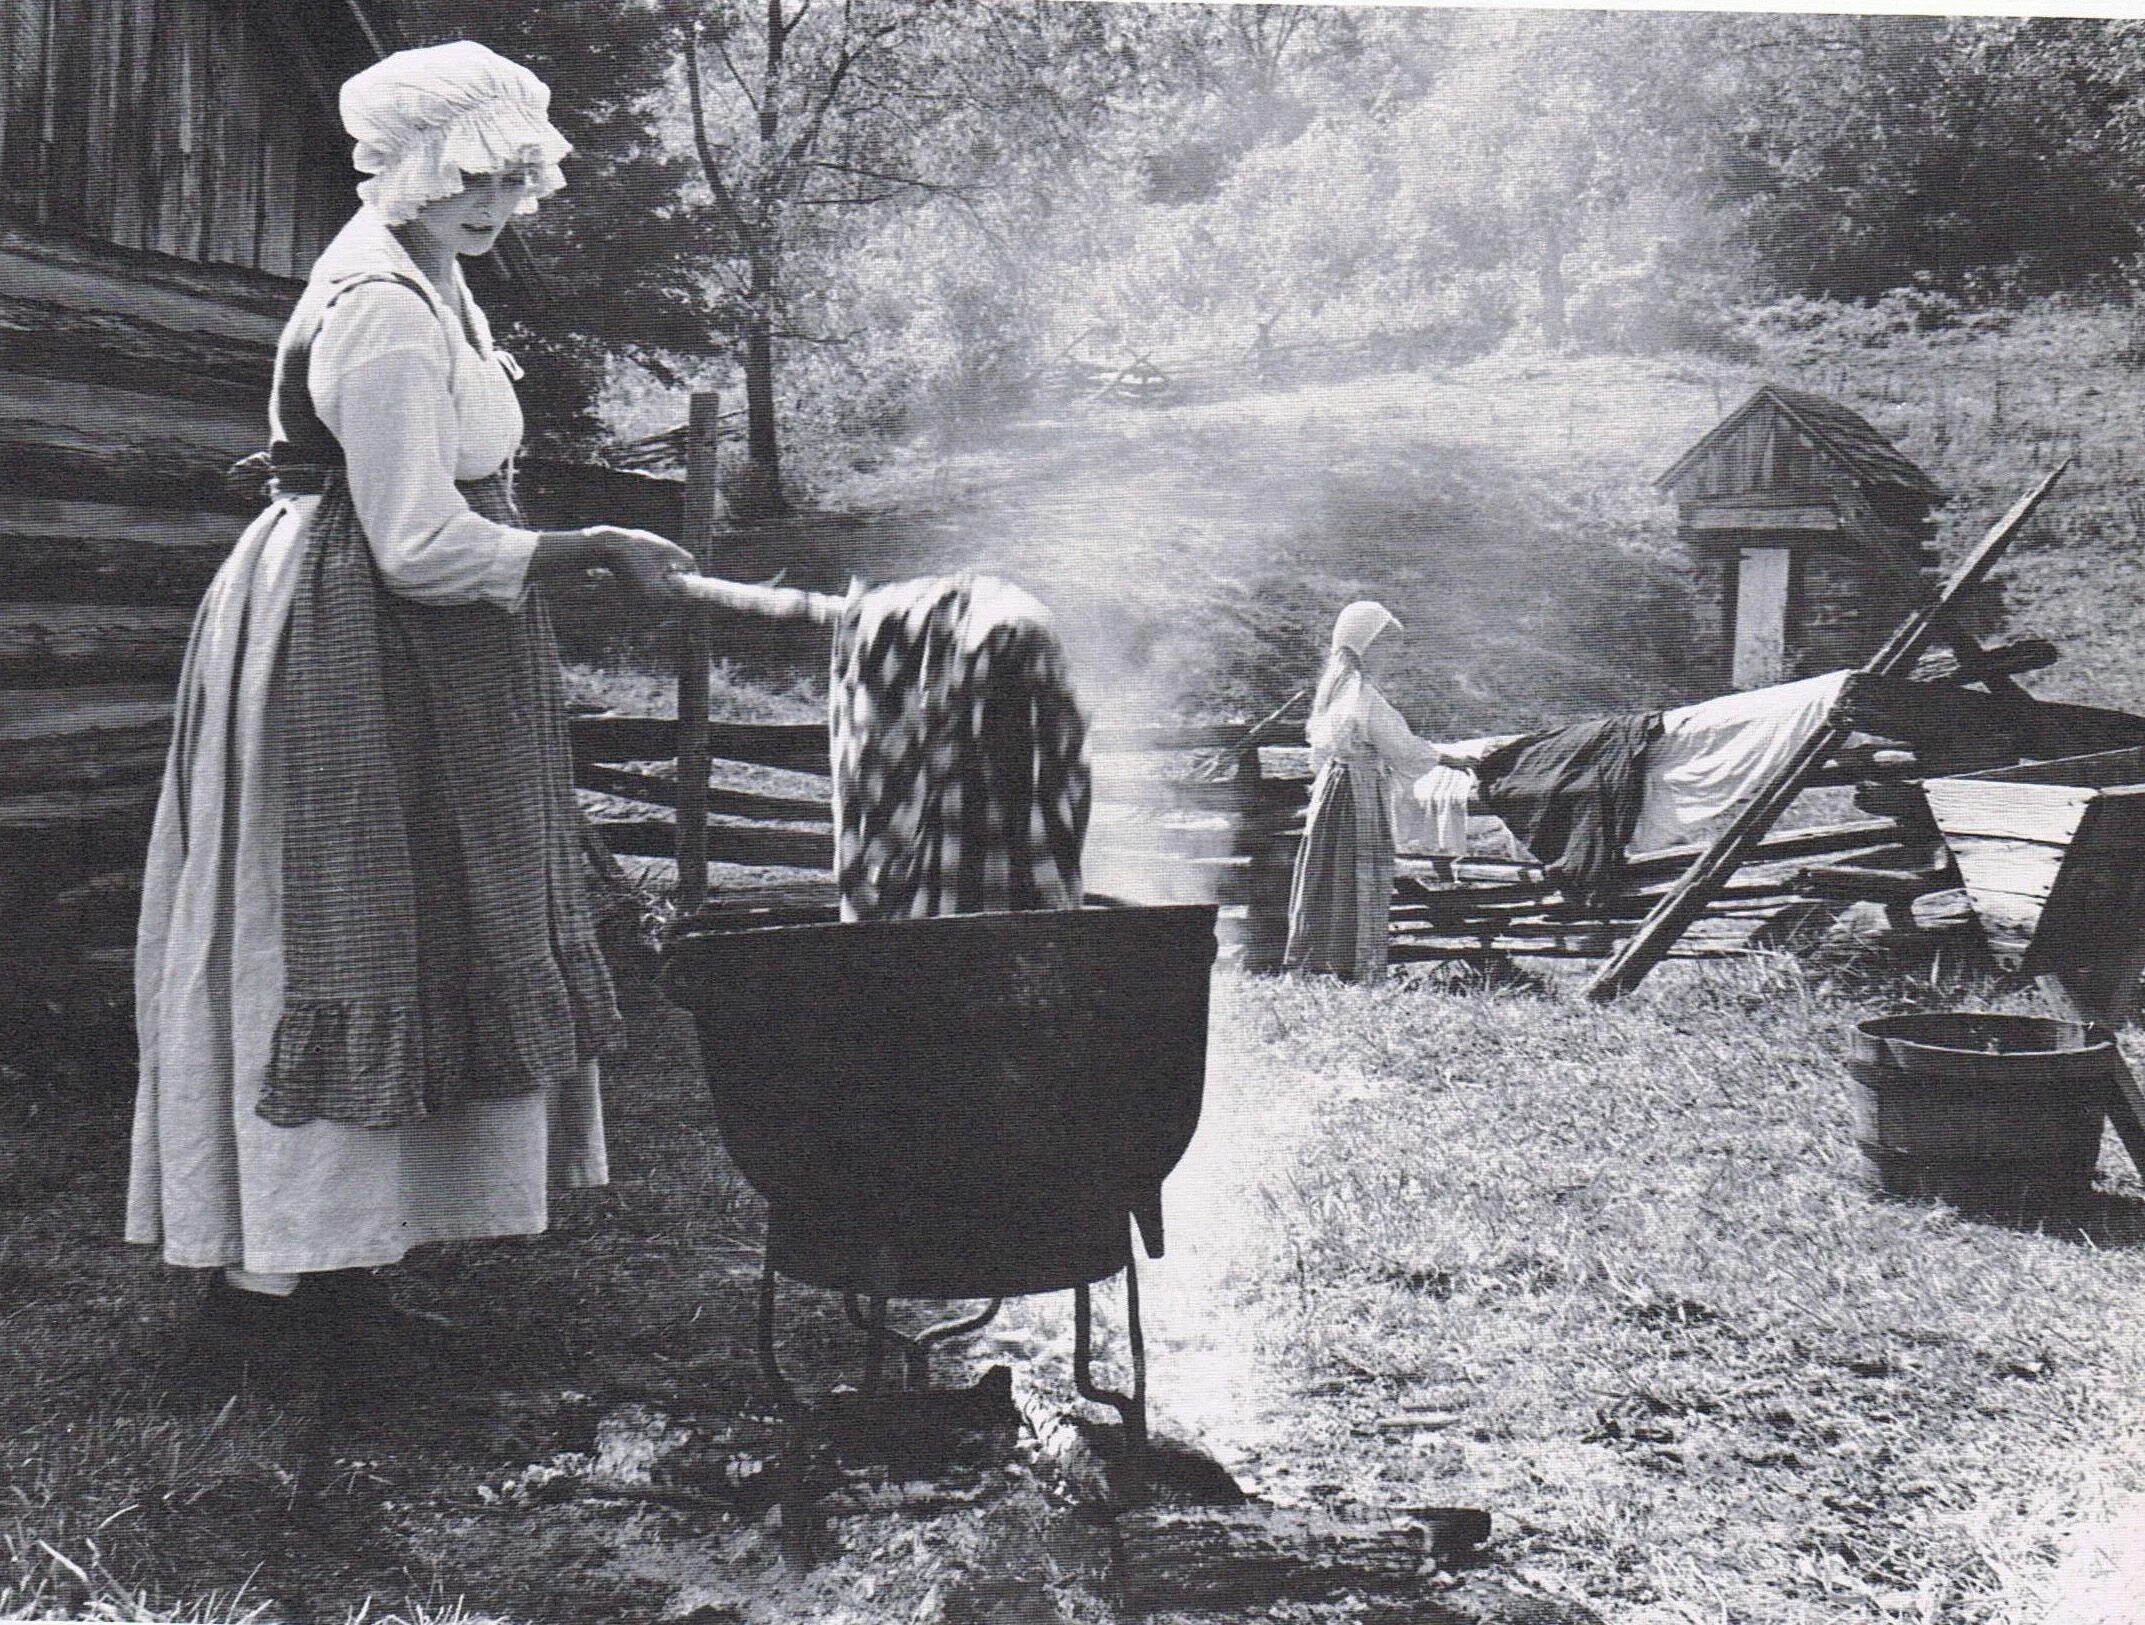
[307,283,536,609]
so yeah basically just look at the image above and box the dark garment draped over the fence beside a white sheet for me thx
[1476,712,1660,913]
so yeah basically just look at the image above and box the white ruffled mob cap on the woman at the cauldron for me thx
[341,39,573,225]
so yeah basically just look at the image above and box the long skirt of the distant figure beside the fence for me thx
[1283,761,1392,982]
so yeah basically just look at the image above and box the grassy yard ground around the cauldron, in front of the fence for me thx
[0,960,2145,1625]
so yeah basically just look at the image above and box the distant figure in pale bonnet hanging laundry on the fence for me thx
[1283,598,1465,982]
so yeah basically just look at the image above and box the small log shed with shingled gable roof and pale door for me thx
[1656,384,1943,688]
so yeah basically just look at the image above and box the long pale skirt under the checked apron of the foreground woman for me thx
[127,497,607,1273]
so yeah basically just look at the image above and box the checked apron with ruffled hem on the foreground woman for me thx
[260,270,620,1128]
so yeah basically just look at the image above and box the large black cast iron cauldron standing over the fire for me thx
[665,905,1214,1432]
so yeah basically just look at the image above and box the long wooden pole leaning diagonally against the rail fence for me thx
[1587,461,2070,1001]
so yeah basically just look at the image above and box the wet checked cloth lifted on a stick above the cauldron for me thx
[828,577,1092,920]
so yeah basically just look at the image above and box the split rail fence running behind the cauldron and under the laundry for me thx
[573,641,2145,967]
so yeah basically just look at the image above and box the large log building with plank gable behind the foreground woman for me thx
[0,0,680,1029]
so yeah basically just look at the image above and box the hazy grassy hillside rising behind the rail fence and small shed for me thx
[669,302,2145,735]
